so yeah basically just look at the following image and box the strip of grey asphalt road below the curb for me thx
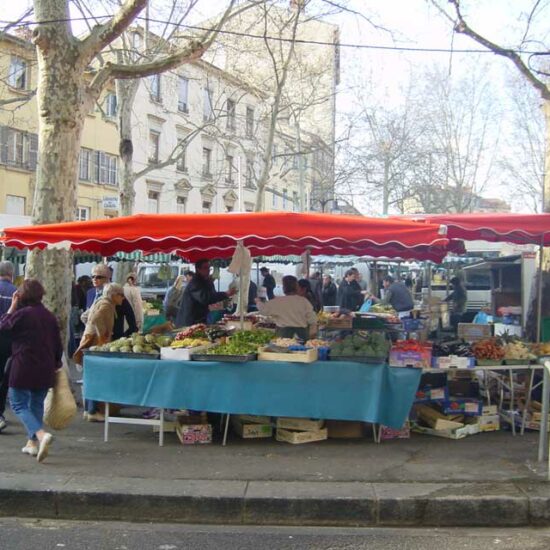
[0,518,550,550]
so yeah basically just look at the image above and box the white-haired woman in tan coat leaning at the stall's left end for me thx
[73,283,125,422]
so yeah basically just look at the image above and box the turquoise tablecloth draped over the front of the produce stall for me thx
[84,356,421,428]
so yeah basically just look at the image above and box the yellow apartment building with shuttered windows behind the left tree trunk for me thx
[0,31,118,225]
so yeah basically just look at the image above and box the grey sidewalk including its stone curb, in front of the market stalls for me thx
[0,416,550,526]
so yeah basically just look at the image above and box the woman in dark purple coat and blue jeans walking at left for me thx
[0,279,63,462]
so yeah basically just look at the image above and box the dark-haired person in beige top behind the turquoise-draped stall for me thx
[256,275,317,340]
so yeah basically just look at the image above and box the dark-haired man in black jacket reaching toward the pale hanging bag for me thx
[176,260,237,328]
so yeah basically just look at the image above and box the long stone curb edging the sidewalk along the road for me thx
[0,474,550,527]
